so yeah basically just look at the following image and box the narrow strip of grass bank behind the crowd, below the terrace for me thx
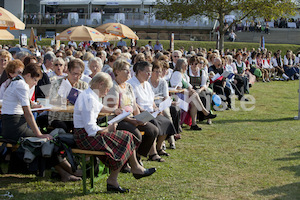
[0,39,300,54]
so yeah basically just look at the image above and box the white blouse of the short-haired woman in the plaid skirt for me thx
[73,88,103,136]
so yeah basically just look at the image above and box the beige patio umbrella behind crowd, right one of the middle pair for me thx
[96,23,139,40]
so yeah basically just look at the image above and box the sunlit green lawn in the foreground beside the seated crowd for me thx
[0,81,300,200]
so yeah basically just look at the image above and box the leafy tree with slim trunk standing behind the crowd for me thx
[156,0,297,50]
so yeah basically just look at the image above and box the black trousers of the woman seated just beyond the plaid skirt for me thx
[117,120,159,157]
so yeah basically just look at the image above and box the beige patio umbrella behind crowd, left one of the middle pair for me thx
[56,25,104,42]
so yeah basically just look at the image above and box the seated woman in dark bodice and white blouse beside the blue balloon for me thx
[187,56,213,124]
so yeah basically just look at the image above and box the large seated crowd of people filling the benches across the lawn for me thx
[0,41,299,193]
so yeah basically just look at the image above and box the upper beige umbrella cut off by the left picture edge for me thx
[0,7,25,30]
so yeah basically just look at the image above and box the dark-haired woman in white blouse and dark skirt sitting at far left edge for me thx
[1,60,81,182]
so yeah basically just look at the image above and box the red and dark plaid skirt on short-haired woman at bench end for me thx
[74,128,140,170]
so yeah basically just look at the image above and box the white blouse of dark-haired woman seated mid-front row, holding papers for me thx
[127,76,154,112]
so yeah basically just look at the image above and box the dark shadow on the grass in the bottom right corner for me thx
[254,182,300,199]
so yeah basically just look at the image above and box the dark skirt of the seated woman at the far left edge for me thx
[1,114,35,141]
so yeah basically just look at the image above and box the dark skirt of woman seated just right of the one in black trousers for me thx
[150,115,177,136]
